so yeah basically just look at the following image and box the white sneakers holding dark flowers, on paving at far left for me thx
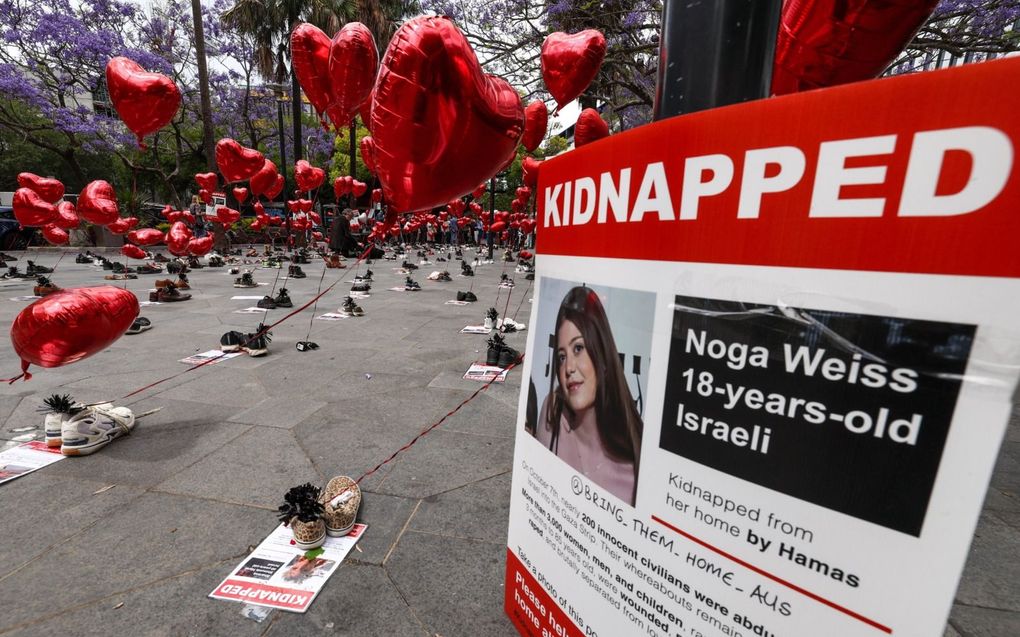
[43,394,135,456]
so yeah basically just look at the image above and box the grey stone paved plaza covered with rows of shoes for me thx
[0,245,1020,637]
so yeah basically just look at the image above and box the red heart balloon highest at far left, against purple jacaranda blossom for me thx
[106,57,181,149]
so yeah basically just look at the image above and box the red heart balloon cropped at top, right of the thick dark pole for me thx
[772,0,938,95]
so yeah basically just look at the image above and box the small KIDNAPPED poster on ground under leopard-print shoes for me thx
[209,524,368,613]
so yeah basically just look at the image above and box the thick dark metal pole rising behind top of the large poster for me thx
[653,0,782,120]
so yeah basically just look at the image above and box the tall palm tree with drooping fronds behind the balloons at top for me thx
[223,0,418,164]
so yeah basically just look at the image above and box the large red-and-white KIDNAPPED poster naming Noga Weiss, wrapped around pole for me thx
[505,59,1020,637]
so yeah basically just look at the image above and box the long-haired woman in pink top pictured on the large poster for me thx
[533,285,643,505]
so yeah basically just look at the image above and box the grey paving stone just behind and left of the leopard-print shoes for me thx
[157,427,322,509]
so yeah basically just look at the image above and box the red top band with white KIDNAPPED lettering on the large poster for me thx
[537,59,1020,276]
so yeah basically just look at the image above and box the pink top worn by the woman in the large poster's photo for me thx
[536,396,634,506]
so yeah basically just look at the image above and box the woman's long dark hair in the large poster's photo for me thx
[548,285,644,495]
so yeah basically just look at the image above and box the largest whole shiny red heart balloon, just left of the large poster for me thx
[370,16,524,212]
